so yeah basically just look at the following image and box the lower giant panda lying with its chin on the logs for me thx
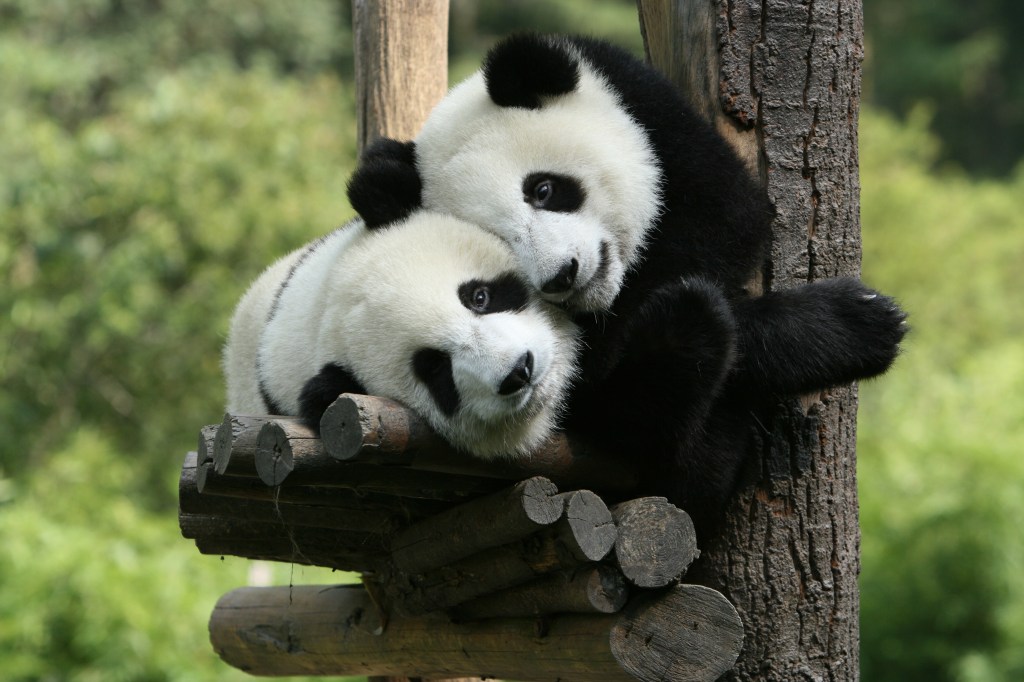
[223,208,577,458]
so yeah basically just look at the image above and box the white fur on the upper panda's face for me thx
[416,43,660,310]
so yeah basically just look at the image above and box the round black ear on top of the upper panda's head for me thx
[483,34,580,109]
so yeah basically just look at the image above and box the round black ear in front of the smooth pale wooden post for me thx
[348,137,423,229]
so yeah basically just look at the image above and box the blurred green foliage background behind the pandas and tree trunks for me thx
[0,0,1024,682]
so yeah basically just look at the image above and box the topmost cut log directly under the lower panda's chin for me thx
[321,393,638,494]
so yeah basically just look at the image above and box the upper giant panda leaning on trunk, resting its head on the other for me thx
[361,34,906,534]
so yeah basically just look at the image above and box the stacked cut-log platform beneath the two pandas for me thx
[179,395,741,679]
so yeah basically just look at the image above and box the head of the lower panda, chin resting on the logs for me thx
[319,211,577,457]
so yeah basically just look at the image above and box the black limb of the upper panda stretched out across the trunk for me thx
[734,278,907,395]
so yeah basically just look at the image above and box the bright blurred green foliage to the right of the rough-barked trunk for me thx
[858,110,1024,682]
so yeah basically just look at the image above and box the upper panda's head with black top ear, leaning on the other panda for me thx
[407,35,660,310]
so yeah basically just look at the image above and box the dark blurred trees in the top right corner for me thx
[864,0,1024,175]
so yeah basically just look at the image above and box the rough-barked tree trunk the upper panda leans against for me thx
[638,0,863,680]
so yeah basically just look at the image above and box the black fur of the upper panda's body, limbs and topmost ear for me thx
[356,36,906,539]
